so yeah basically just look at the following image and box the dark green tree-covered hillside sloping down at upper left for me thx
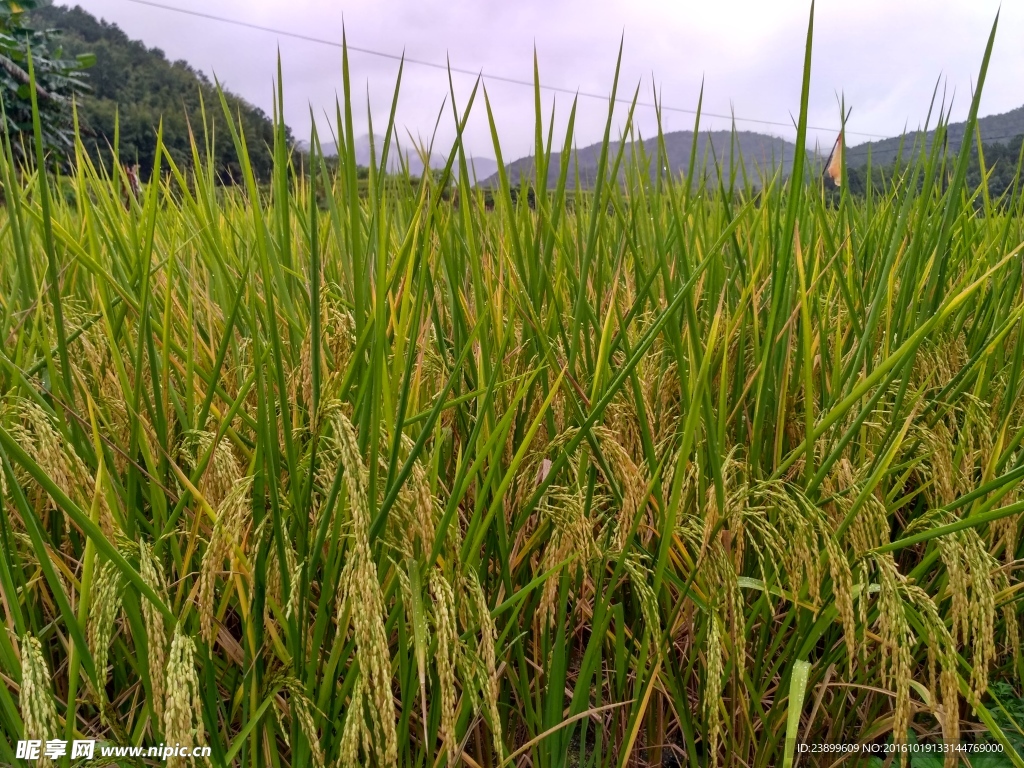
[31,5,291,183]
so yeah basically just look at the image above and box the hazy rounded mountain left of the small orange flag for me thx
[481,131,811,187]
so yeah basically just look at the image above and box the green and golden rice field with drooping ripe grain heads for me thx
[0,15,1024,768]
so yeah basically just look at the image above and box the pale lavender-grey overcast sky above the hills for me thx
[68,0,1011,162]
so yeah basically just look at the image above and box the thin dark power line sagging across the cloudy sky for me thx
[117,0,889,139]
